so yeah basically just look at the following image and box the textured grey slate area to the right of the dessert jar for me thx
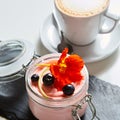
[83,76,120,120]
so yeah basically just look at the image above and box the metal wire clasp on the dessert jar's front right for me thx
[72,94,100,120]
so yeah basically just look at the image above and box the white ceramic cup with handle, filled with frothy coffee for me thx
[53,0,118,45]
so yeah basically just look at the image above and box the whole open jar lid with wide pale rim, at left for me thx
[0,40,34,77]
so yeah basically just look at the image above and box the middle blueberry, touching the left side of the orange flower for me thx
[43,73,54,86]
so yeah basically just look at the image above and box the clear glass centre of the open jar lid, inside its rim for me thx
[0,41,25,66]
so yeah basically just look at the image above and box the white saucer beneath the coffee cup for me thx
[41,14,120,63]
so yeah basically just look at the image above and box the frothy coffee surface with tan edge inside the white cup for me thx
[55,0,109,17]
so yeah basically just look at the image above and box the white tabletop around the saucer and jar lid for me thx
[0,0,120,86]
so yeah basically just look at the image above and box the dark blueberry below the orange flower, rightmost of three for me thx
[62,84,75,95]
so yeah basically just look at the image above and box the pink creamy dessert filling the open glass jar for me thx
[26,53,89,120]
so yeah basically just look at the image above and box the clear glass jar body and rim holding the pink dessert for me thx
[25,53,89,120]
